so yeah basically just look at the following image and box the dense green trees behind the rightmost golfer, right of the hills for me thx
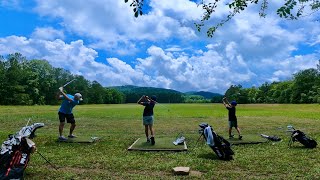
[225,61,320,104]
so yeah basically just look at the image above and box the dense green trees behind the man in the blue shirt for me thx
[0,53,124,105]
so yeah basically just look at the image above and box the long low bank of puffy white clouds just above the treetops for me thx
[0,36,317,93]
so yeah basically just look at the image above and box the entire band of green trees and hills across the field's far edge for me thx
[0,53,320,105]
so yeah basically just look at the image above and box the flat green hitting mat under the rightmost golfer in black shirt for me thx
[226,134,268,145]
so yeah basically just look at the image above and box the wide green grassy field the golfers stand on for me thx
[0,104,320,179]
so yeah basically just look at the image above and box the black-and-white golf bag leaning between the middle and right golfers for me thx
[199,123,234,161]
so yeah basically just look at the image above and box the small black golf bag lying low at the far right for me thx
[289,129,317,149]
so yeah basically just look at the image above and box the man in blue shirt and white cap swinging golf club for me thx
[58,87,83,141]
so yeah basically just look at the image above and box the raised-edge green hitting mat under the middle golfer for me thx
[128,137,188,151]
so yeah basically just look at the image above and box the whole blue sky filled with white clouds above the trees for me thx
[0,0,320,93]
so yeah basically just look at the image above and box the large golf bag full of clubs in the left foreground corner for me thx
[0,123,44,180]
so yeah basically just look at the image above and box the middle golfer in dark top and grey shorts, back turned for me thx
[137,95,157,145]
